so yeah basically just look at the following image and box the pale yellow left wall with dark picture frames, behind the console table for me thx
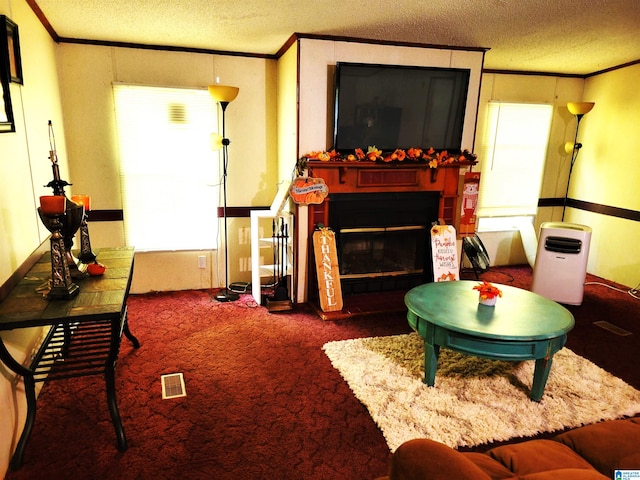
[0,0,68,478]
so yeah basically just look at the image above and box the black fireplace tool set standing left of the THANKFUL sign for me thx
[266,217,293,312]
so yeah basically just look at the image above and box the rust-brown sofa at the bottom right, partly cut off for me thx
[380,417,640,480]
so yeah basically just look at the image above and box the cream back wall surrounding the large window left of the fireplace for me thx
[59,44,278,293]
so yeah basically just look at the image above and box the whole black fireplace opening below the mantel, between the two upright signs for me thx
[329,192,440,295]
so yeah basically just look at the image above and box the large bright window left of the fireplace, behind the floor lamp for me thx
[113,84,220,251]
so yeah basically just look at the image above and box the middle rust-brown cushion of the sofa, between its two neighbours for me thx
[487,440,595,476]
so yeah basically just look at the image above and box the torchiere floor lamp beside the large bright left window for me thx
[209,85,240,302]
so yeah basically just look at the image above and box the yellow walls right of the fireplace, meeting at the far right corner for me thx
[478,65,640,287]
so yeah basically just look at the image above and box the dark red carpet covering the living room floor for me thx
[7,267,640,480]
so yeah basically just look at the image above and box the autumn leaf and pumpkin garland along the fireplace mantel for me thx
[298,146,477,172]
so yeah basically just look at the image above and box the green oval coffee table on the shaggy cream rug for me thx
[405,280,575,401]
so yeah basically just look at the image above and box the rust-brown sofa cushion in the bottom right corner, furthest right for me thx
[554,418,640,478]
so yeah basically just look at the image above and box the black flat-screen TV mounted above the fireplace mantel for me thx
[333,63,470,152]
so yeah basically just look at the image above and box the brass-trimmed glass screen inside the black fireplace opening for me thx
[338,226,426,279]
